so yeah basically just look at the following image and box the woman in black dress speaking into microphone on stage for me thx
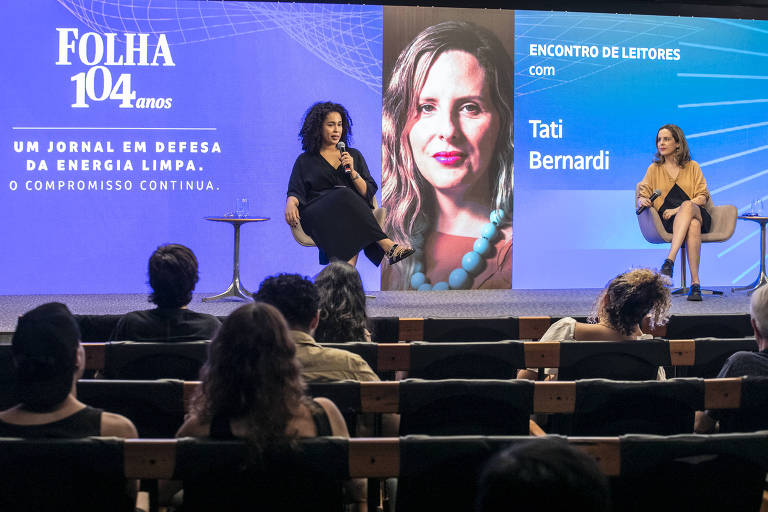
[285,101,413,266]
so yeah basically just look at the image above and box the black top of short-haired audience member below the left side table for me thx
[110,308,221,341]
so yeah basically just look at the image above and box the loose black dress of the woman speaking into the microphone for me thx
[288,148,387,265]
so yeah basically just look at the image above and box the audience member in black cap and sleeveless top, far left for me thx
[0,302,138,438]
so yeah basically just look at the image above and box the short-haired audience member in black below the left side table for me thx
[110,244,221,341]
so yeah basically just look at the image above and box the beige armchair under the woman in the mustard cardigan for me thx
[635,187,738,295]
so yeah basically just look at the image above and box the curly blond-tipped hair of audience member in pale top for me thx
[589,268,671,336]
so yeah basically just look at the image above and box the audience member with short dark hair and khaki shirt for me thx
[254,274,379,382]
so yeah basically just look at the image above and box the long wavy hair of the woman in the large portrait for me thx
[381,21,514,289]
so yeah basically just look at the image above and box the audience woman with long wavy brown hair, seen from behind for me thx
[176,302,365,506]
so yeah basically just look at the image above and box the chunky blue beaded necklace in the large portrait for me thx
[410,210,506,292]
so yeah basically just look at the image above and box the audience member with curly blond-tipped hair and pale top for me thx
[517,268,671,380]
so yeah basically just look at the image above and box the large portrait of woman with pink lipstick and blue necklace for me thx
[382,21,514,290]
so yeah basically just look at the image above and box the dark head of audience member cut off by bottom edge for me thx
[475,439,610,512]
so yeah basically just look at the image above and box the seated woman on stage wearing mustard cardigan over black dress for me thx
[636,124,712,301]
